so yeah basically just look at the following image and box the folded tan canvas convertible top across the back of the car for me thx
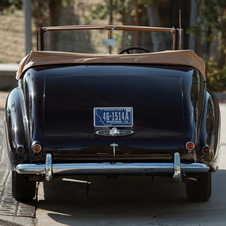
[16,50,206,80]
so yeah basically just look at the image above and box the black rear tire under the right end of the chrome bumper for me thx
[186,172,212,202]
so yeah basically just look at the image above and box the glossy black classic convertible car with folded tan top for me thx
[5,25,220,202]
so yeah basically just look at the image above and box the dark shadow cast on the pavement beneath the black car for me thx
[37,170,226,225]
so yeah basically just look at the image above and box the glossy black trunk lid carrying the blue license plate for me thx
[43,65,186,161]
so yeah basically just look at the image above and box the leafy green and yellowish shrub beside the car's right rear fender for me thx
[206,61,226,92]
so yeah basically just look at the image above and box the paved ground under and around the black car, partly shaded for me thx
[0,92,226,226]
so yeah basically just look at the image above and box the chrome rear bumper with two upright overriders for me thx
[15,152,210,181]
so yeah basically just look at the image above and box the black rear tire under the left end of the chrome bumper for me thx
[12,171,36,202]
